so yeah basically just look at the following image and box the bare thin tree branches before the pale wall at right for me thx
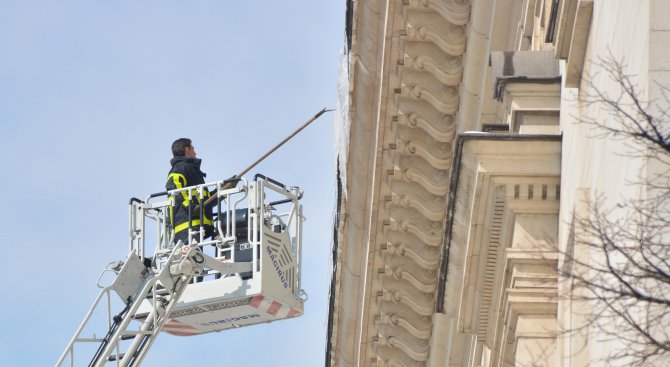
[559,53,670,365]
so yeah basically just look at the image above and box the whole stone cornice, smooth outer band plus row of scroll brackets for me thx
[327,0,470,366]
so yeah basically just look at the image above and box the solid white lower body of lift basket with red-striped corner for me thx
[137,228,304,336]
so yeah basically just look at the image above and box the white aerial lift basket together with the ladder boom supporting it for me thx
[56,175,307,367]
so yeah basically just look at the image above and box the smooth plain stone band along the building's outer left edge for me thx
[326,0,392,366]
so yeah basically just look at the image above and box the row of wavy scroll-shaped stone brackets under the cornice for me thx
[372,1,469,366]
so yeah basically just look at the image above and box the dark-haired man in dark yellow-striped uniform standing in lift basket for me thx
[165,138,214,244]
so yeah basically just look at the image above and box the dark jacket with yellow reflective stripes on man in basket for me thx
[165,156,213,236]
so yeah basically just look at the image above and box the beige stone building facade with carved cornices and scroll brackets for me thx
[326,0,670,367]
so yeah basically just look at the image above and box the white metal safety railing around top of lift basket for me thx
[129,174,303,296]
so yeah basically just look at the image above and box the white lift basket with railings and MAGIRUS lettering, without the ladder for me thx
[130,175,306,336]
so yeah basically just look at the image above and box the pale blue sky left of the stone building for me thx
[0,0,345,367]
